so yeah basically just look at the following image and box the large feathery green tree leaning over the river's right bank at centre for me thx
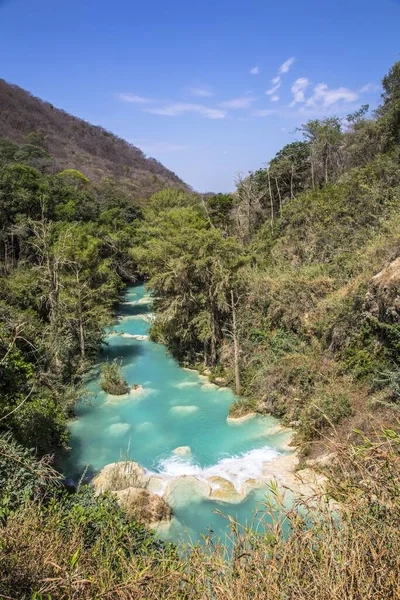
[134,198,246,366]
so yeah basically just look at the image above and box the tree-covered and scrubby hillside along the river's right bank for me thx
[133,63,400,452]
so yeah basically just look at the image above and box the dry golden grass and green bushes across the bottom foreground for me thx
[0,429,400,600]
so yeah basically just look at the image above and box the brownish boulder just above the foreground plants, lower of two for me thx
[115,487,172,525]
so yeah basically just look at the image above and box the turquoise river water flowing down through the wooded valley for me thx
[64,285,288,542]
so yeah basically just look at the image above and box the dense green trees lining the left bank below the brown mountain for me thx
[0,140,147,455]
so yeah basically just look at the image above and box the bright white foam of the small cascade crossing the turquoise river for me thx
[152,446,280,492]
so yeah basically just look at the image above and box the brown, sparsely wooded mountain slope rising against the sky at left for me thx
[0,79,189,198]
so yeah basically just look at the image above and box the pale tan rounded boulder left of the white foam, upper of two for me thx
[92,460,149,494]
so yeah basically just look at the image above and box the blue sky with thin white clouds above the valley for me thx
[0,0,400,191]
